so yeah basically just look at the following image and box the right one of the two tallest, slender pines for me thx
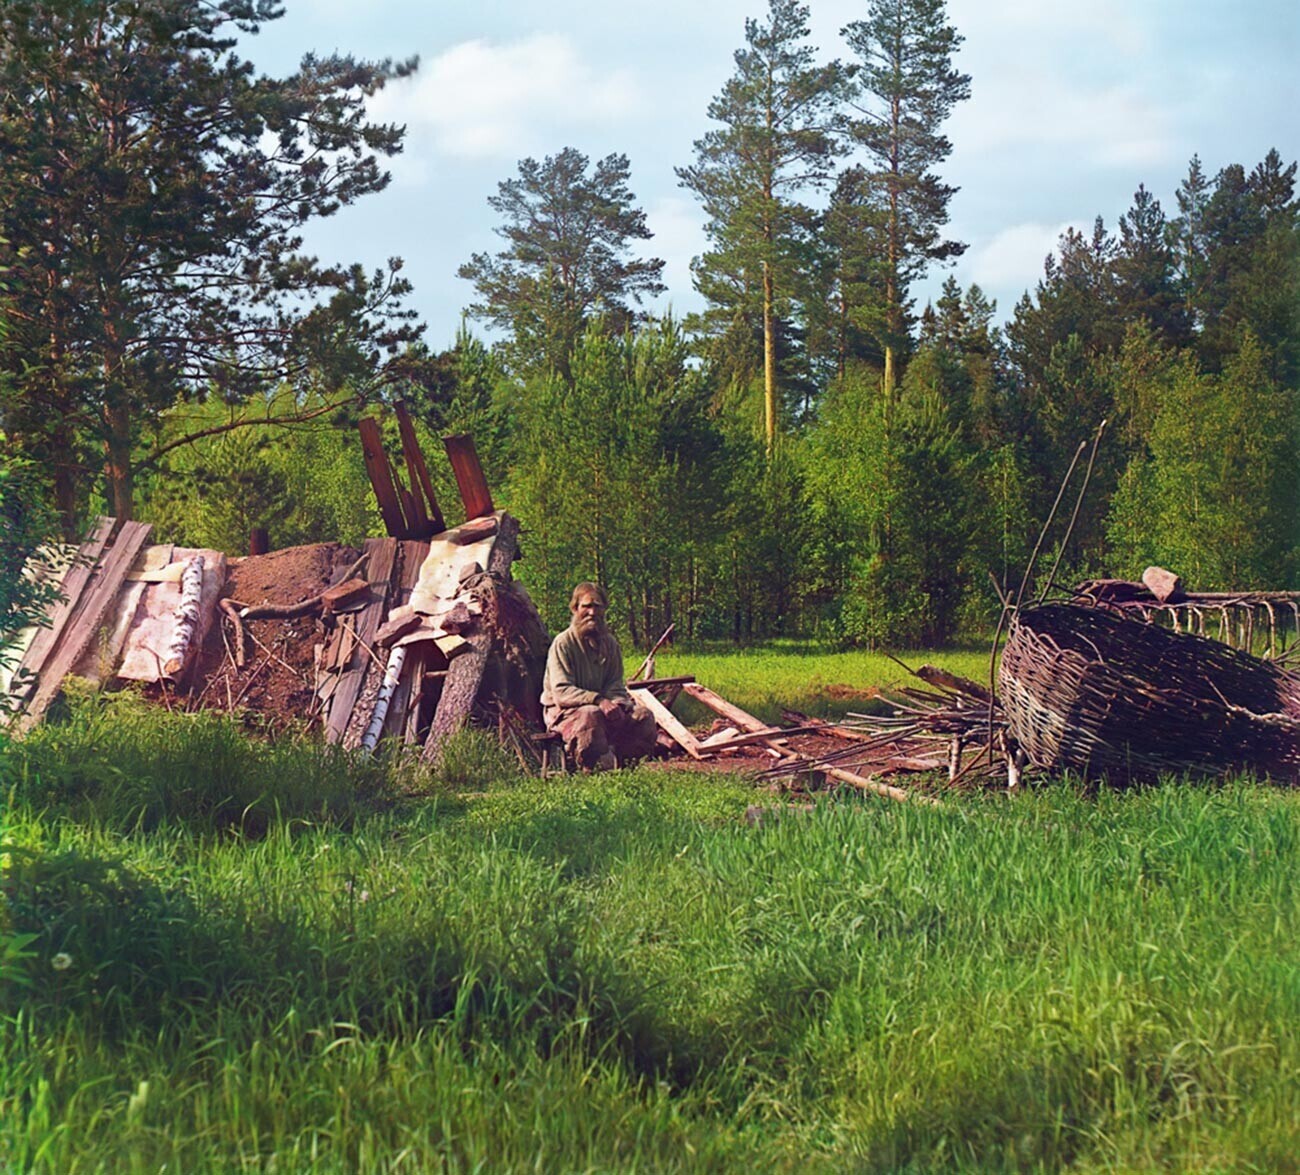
[844,0,970,399]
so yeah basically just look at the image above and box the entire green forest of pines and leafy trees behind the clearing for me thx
[0,0,1300,647]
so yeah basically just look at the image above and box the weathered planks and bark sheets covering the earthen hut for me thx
[8,411,550,759]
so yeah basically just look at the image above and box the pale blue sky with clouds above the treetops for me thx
[241,0,1300,350]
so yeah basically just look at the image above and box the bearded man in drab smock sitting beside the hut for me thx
[542,584,658,771]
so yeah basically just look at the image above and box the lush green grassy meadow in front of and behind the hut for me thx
[0,649,1300,1172]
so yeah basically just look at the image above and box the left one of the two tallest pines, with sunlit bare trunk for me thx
[677,0,845,455]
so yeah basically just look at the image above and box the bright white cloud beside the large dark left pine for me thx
[371,32,642,159]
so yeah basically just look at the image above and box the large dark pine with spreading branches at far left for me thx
[0,0,415,528]
